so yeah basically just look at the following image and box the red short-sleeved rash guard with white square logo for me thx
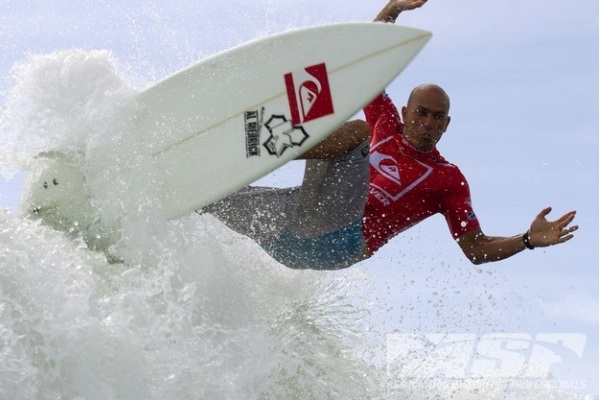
[362,94,479,254]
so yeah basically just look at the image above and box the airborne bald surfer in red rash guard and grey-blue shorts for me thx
[203,0,577,270]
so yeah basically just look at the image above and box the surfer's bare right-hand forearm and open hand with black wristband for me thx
[457,207,578,264]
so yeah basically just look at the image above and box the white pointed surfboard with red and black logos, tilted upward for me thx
[22,23,431,227]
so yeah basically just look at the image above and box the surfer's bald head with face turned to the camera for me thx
[402,84,450,152]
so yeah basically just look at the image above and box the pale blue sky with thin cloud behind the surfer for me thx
[0,0,599,392]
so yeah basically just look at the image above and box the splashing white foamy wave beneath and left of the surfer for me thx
[0,50,597,400]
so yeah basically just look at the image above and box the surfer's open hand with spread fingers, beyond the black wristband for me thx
[529,207,579,247]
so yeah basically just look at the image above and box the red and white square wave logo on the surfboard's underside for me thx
[283,63,334,125]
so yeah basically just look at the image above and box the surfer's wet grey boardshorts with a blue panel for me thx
[209,121,369,269]
